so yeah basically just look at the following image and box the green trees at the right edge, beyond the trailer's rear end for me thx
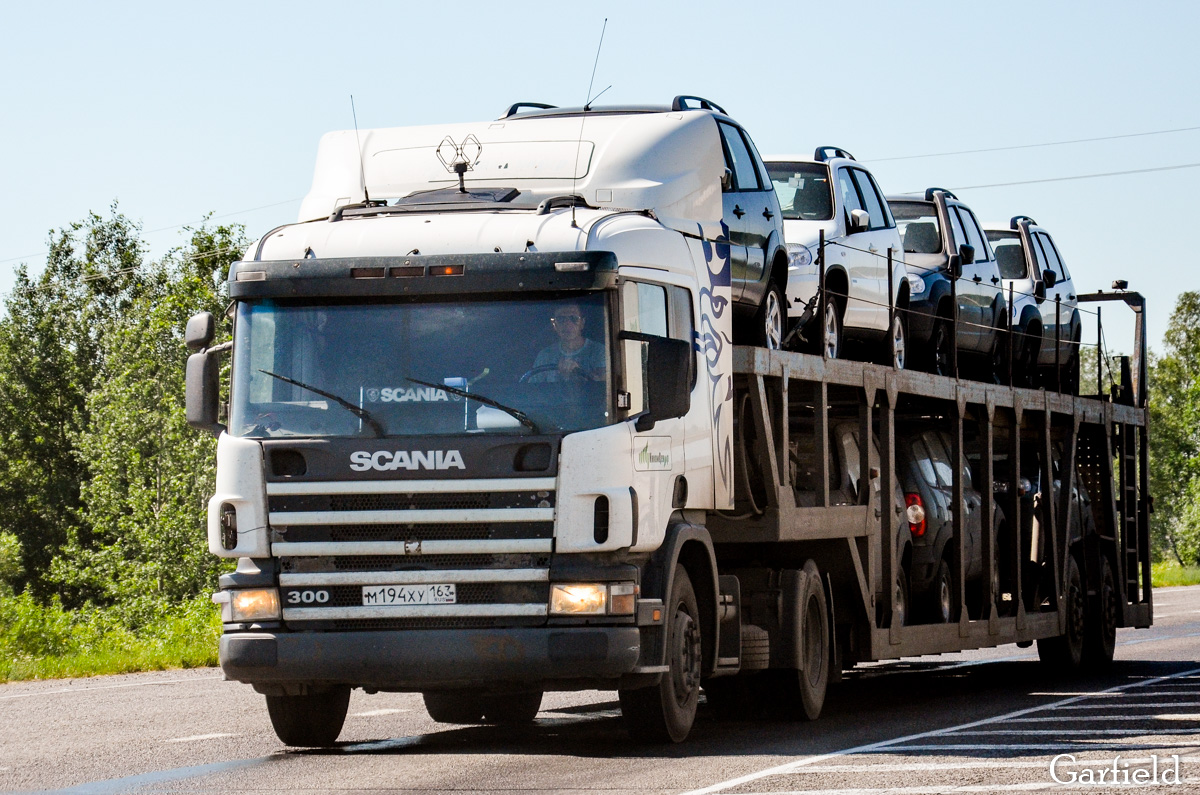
[1150,292,1200,564]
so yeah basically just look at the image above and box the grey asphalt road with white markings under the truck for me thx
[0,586,1200,795]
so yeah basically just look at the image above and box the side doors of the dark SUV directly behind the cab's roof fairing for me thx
[716,121,766,301]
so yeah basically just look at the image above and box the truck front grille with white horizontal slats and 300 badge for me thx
[266,478,554,629]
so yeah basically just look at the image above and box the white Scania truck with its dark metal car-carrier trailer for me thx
[187,97,1150,746]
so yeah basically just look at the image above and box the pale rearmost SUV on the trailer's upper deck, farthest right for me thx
[984,215,1082,394]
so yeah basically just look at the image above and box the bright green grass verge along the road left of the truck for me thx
[0,594,221,682]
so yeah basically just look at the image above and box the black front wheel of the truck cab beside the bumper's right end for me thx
[618,566,702,742]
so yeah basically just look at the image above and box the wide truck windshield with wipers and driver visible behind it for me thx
[229,294,614,437]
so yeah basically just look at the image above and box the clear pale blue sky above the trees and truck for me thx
[0,0,1200,351]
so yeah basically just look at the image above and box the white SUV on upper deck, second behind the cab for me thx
[766,147,908,367]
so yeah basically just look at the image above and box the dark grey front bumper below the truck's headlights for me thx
[221,626,641,691]
